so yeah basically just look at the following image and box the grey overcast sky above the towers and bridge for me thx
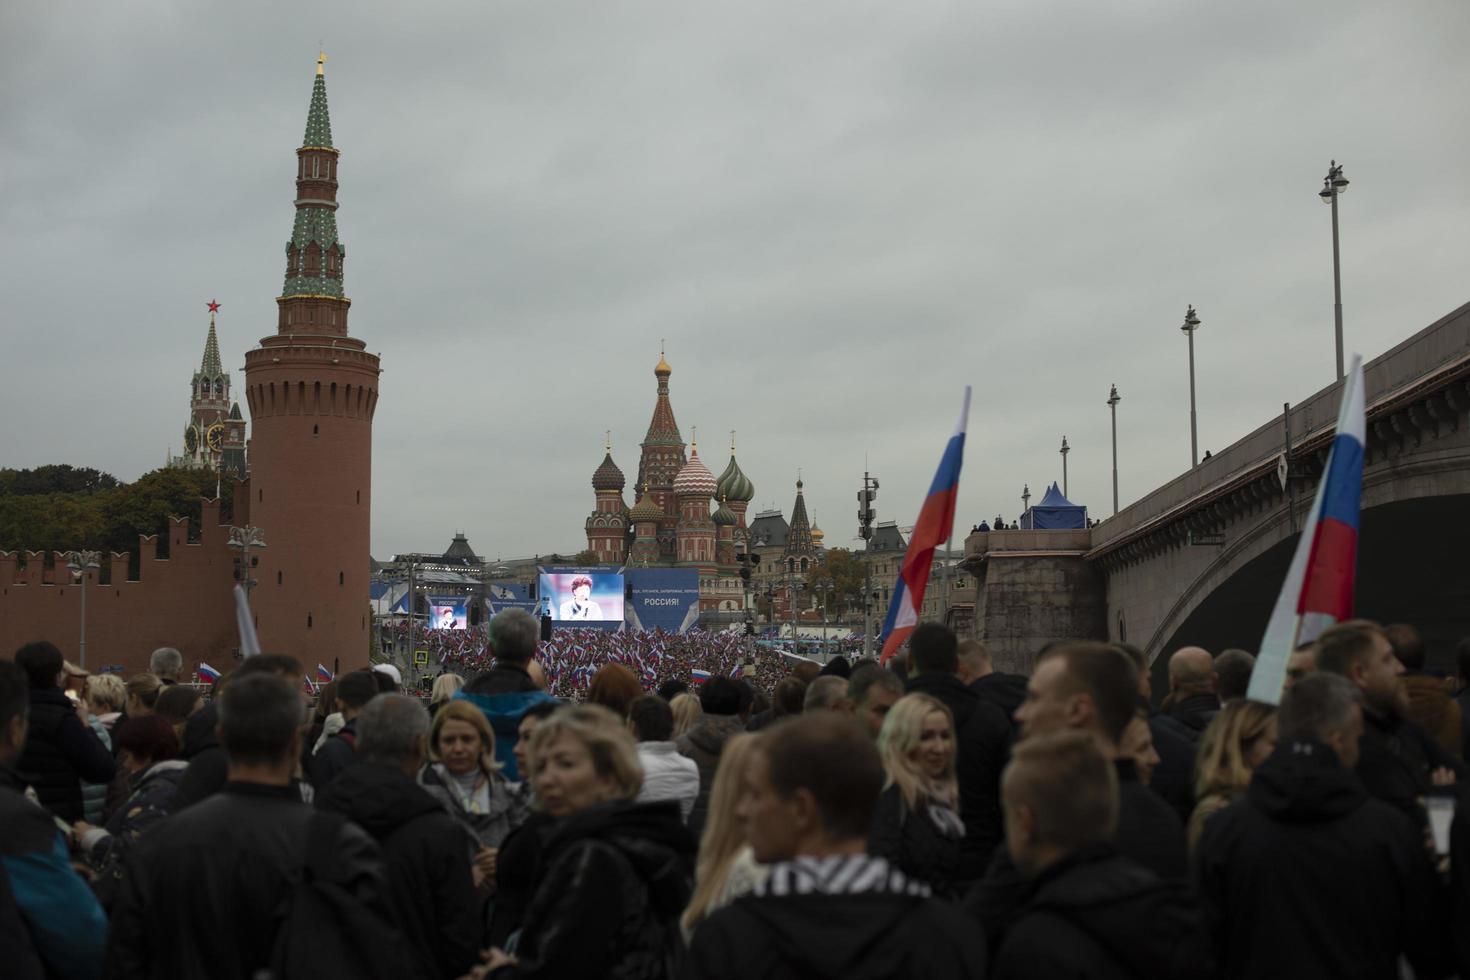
[0,0,1470,558]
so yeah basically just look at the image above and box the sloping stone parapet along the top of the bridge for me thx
[1092,303,1470,548]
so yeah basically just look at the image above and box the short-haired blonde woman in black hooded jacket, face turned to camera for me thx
[484,704,695,980]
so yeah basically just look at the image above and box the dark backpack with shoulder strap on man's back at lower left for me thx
[270,811,420,980]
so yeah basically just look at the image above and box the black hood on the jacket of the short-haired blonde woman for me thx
[542,801,697,915]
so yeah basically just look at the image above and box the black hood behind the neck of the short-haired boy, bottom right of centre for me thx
[1022,845,1214,980]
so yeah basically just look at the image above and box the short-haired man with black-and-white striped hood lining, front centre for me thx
[684,711,985,980]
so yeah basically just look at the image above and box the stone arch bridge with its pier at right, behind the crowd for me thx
[964,303,1470,670]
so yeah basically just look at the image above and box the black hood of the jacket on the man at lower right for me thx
[1247,741,1369,823]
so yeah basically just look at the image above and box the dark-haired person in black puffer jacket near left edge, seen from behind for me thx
[15,641,118,824]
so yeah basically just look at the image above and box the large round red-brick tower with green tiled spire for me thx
[237,54,381,670]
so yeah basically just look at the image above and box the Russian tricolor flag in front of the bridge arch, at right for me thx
[1245,354,1367,704]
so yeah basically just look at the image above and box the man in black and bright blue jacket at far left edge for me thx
[0,661,107,979]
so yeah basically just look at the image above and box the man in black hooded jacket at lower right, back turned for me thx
[1195,671,1449,980]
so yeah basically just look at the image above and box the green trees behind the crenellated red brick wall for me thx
[0,466,234,564]
